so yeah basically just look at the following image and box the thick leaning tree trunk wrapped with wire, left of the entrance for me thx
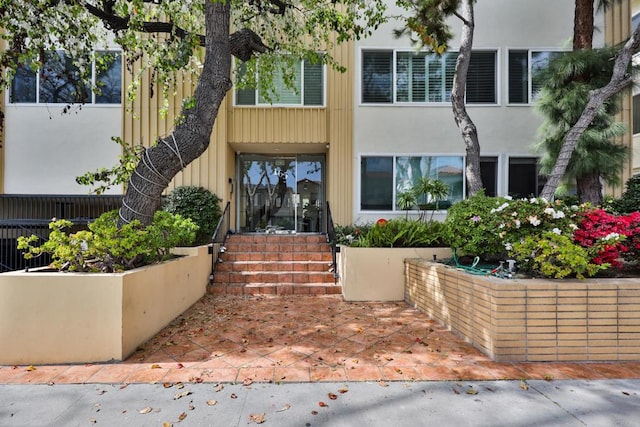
[120,0,232,225]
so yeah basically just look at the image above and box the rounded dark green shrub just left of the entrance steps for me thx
[163,186,222,245]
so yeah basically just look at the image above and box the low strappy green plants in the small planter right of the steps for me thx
[352,218,445,248]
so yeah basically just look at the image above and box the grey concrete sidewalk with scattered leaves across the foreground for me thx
[0,379,640,427]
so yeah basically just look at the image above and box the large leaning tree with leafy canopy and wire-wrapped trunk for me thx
[0,0,385,224]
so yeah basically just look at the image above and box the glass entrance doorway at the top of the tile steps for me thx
[237,154,326,233]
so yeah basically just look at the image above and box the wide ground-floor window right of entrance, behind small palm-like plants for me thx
[360,156,464,211]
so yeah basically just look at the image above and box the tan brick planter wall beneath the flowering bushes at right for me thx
[405,259,640,362]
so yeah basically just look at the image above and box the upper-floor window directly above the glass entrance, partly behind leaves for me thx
[236,61,324,106]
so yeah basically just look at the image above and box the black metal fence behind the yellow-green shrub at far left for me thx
[0,194,123,272]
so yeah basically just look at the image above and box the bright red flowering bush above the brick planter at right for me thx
[573,209,640,268]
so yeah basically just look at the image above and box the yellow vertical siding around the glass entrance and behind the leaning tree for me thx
[123,43,353,224]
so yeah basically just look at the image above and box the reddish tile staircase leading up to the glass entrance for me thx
[208,233,342,295]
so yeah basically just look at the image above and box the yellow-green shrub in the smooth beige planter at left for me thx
[18,210,198,272]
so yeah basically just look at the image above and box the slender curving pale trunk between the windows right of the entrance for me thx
[451,0,482,196]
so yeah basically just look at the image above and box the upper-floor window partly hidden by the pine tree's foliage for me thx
[508,50,563,104]
